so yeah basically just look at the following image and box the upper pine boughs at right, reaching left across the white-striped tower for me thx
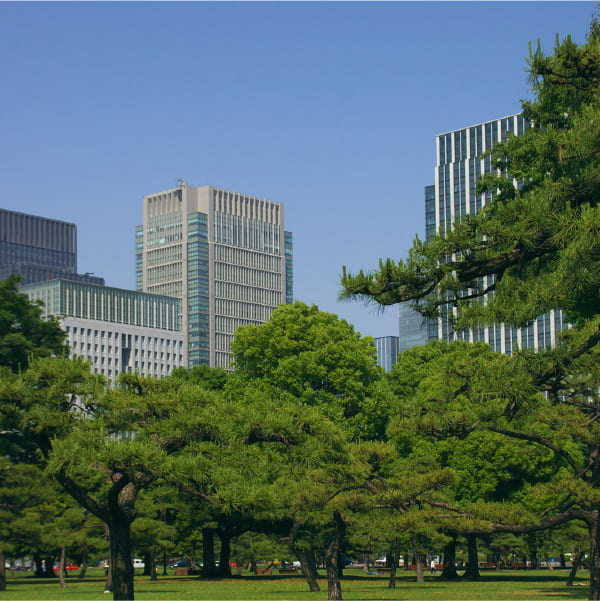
[342,20,600,328]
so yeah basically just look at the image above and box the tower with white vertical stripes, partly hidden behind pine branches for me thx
[420,115,566,355]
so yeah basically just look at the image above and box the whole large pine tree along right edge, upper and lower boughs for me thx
[341,18,600,599]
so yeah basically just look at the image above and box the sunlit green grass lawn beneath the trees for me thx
[0,569,588,601]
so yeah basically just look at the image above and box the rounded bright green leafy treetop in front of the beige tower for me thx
[232,302,381,438]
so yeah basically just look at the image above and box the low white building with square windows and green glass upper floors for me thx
[21,279,187,382]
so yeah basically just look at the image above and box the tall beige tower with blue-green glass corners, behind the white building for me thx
[136,182,293,369]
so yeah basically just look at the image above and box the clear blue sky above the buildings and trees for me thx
[0,2,597,336]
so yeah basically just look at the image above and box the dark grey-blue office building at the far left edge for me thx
[0,209,104,285]
